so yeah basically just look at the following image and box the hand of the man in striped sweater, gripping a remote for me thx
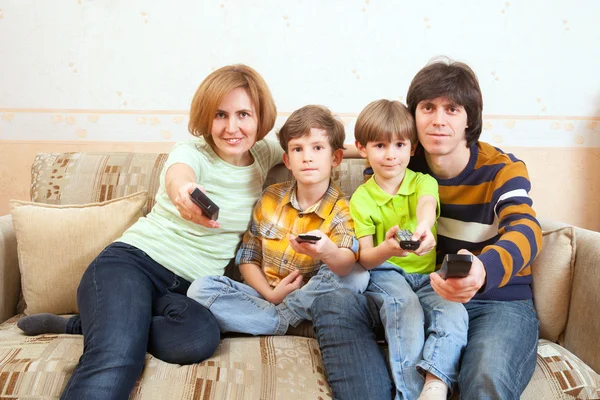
[429,249,486,303]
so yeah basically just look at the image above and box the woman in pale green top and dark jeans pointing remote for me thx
[18,65,283,399]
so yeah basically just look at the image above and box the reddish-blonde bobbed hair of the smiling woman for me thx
[188,64,277,142]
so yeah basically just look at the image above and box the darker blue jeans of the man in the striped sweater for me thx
[312,290,539,400]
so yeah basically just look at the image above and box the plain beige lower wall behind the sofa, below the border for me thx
[0,141,600,231]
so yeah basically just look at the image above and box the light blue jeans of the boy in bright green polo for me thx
[365,263,469,399]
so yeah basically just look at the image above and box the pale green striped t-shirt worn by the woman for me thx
[117,138,283,282]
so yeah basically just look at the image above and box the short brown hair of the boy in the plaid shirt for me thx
[277,105,346,153]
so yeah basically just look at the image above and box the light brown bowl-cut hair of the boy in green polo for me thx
[354,99,417,146]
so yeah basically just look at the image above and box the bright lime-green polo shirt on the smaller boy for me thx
[350,169,440,274]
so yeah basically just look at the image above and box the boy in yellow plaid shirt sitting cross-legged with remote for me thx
[188,105,369,335]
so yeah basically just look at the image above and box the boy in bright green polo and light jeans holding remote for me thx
[350,100,468,399]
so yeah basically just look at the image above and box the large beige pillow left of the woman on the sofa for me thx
[9,191,146,315]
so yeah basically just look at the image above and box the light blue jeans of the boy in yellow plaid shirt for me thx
[188,264,369,335]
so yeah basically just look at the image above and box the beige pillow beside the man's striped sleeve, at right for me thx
[531,226,575,342]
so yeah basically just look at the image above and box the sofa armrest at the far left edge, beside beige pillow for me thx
[0,215,21,321]
